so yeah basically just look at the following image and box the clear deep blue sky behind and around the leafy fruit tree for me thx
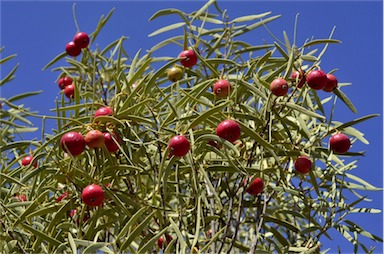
[1,0,383,253]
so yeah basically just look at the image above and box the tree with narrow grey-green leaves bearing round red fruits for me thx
[1,1,382,253]
